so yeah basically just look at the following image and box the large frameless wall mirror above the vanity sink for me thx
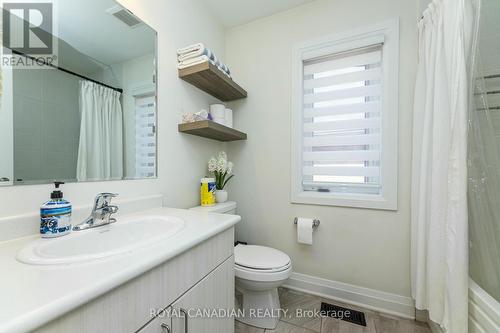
[0,0,157,186]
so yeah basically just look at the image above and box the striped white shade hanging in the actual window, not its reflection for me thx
[302,43,383,194]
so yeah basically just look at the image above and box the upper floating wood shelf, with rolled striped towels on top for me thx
[179,61,247,102]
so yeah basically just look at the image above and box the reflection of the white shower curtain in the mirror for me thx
[77,81,123,181]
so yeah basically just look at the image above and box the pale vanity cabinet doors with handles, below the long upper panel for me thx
[138,257,234,333]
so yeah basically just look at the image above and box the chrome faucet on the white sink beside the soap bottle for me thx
[73,193,118,231]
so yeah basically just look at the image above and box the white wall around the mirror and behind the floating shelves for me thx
[0,0,224,218]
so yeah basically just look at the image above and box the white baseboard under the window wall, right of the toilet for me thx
[284,272,415,319]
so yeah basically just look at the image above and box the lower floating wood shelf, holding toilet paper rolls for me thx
[179,120,247,141]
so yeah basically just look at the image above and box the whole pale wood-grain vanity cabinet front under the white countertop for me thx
[34,228,234,333]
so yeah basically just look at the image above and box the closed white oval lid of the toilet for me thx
[234,244,290,269]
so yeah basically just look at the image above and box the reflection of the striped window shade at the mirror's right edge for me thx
[135,96,156,178]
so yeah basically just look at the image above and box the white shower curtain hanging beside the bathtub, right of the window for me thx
[411,0,473,333]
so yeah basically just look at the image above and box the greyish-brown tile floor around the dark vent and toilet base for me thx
[235,288,431,333]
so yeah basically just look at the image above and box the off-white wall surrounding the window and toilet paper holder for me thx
[226,0,418,296]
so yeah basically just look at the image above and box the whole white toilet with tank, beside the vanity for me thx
[191,201,292,329]
